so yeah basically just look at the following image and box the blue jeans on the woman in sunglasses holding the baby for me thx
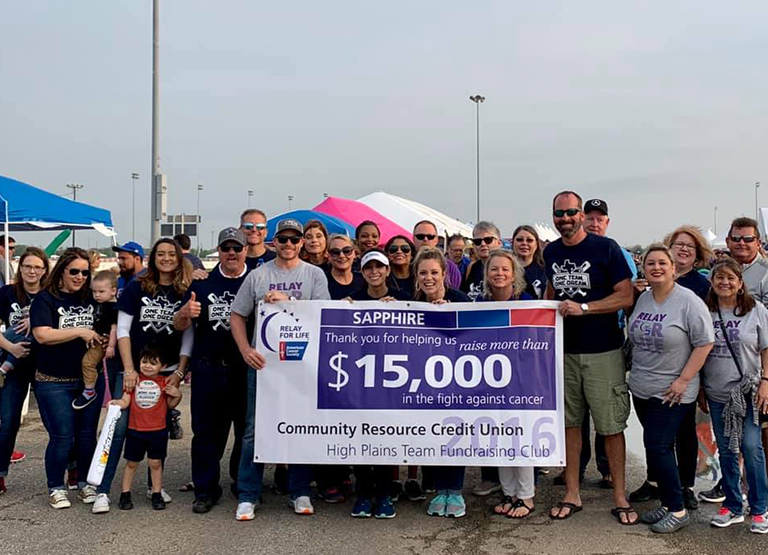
[35,375,104,491]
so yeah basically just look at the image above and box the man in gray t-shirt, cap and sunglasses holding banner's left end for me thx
[230,219,331,520]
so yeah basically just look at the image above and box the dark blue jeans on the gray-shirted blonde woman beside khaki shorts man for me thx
[632,396,696,512]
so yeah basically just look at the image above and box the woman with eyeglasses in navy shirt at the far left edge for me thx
[0,247,50,495]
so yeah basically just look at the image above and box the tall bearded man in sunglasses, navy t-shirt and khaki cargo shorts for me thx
[544,191,639,525]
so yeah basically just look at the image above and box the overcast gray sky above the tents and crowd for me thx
[0,0,768,250]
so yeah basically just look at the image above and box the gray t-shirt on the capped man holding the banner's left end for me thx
[231,260,331,347]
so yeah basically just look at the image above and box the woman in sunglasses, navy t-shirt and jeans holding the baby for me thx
[29,248,104,509]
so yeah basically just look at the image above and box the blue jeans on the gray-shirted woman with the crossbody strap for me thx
[708,401,768,515]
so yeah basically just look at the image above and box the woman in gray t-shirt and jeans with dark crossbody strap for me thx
[699,258,768,534]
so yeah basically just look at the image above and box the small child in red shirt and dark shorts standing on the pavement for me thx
[110,344,181,511]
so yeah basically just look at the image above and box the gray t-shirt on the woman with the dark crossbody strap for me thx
[701,303,768,403]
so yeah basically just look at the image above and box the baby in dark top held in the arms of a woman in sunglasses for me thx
[72,270,117,410]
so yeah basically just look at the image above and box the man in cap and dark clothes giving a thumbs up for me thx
[173,227,253,513]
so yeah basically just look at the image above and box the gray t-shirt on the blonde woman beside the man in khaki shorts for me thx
[629,284,715,403]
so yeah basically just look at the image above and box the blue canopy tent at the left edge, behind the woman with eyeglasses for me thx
[0,175,115,278]
